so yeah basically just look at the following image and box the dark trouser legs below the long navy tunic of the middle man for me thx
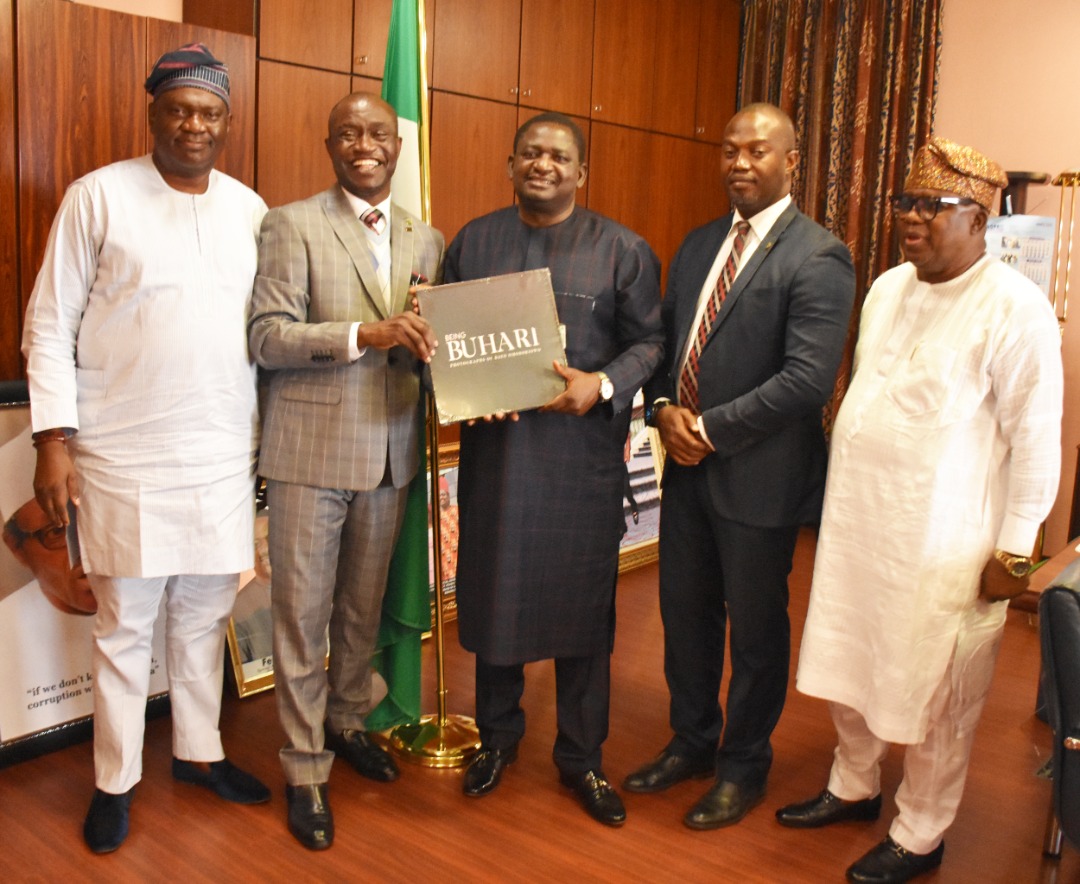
[476,650,611,774]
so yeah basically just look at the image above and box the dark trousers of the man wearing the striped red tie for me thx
[660,464,798,787]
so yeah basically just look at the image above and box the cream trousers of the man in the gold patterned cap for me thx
[828,626,1001,854]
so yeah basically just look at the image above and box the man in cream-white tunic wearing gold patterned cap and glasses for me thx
[777,137,1062,882]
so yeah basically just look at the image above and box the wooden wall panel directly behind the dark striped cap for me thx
[144,18,258,187]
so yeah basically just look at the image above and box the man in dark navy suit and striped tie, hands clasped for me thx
[624,104,854,829]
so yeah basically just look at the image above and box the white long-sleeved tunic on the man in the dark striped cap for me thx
[23,155,266,576]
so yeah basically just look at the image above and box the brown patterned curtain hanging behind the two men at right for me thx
[739,0,942,403]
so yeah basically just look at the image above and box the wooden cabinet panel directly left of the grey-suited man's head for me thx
[256,60,350,206]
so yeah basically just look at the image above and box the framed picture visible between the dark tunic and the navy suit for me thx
[619,392,664,573]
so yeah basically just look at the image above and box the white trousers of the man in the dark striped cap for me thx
[90,574,239,794]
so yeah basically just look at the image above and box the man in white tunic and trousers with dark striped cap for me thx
[23,43,270,853]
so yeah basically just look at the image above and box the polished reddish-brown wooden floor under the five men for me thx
[0,533,1080,884]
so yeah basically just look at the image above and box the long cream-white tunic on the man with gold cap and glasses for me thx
[797,256,1062,744]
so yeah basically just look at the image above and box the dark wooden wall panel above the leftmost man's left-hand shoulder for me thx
[17,0,147,328]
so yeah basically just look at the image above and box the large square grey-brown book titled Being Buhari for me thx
[417,268,566,426]
